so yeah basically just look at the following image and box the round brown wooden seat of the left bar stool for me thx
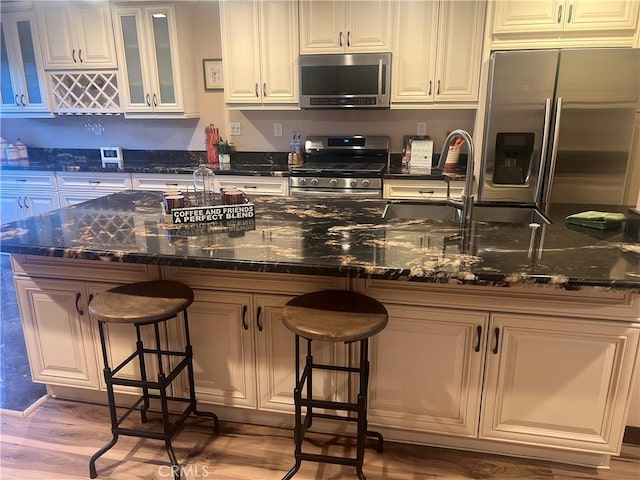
[89,280,193,324]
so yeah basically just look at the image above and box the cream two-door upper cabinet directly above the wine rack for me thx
[36,1,118,69]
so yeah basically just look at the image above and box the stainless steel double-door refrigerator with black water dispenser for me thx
[478,48,640,212]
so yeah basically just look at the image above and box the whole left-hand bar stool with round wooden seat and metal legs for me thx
[89,281,220,480]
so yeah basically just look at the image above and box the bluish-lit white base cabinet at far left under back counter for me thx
[0,170,59,223]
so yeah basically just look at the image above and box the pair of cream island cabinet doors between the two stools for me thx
[176,289,337,412]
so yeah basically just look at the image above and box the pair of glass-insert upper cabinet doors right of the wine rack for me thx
[115,6,181,111]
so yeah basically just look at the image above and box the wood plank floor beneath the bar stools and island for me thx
[0,399,640,480]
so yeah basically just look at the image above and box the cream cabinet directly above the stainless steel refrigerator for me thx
[491,0,640,48]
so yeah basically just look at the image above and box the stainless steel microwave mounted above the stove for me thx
[299,53,391,109]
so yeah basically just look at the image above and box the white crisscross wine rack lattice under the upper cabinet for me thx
[49,71,122,114]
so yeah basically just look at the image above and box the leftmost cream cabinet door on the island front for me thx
[15,277,98,389]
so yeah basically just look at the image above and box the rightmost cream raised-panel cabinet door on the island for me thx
[480,314,639,454]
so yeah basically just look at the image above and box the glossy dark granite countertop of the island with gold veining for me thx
[0,191,640,291]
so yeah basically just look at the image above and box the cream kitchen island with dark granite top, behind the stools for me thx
[0,192,640,466]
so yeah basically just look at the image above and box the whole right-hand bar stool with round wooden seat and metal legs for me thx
[282,290,388,480]
